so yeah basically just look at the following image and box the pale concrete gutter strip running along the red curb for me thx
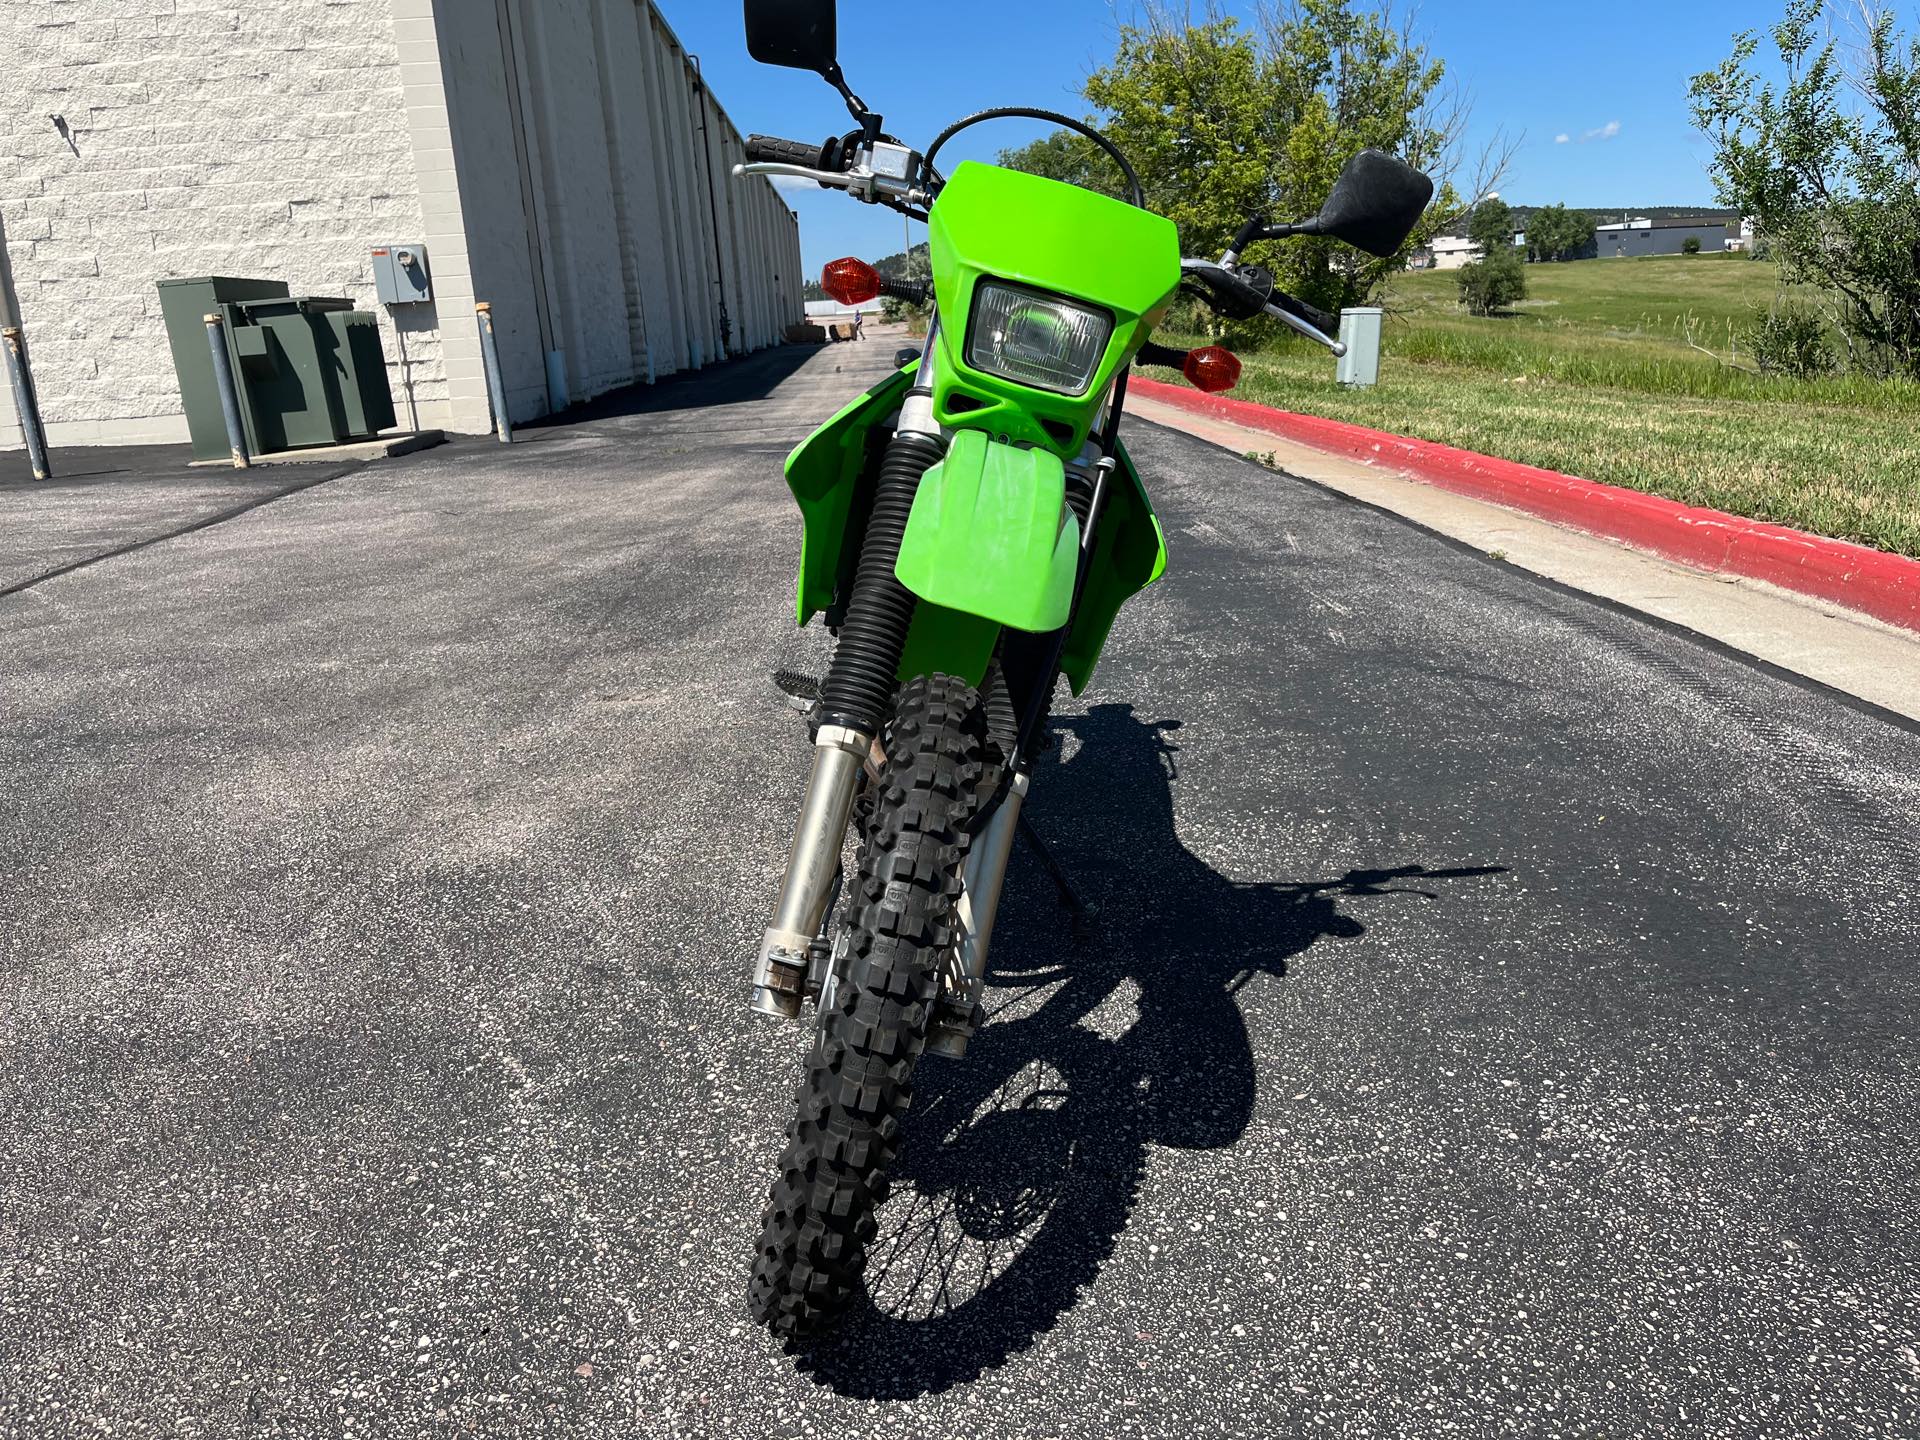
[1127,376,1920,733]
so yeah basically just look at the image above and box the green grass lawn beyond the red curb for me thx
[1190,255,1920,557]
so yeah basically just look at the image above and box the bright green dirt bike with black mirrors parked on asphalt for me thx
[733,0,1432,1338]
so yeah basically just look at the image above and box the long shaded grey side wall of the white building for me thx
[424,0,801,422]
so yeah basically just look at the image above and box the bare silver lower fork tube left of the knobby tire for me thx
[749,726,874,1020]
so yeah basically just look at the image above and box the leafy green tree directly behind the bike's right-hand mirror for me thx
[1000,0,1463,309]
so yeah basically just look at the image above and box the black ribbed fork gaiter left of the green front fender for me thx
[820,430,941,735]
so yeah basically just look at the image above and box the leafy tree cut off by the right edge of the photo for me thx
[1692,0,1920,376]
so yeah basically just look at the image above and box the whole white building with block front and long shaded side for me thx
[0,0,803,447]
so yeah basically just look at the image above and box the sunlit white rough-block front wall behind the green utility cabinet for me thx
[0,0,451,444]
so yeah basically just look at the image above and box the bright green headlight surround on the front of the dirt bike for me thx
[927,161,1181,459]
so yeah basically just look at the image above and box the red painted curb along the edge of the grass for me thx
[1127,376,1920,630]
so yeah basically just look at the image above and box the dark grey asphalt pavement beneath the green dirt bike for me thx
[0,338,1920,1440]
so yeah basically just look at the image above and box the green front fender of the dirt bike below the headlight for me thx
[893,430,1079,632]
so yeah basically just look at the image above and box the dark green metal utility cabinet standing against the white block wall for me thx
[159,276,394,459]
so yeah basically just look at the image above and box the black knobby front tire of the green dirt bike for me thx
[747,676,996,1340]
